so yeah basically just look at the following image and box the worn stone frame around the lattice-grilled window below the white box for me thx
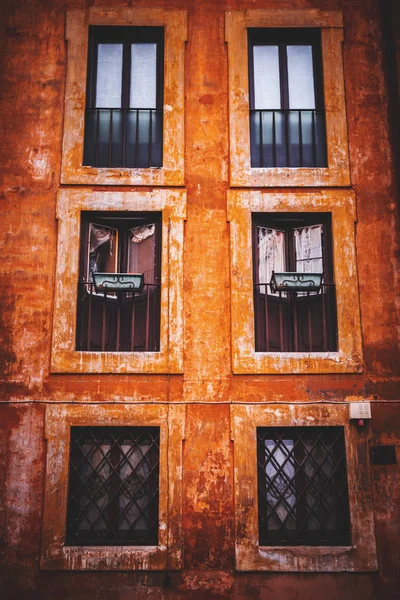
[231,402,377,572]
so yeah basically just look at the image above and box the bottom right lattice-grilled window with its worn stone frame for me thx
[230,404,377,572]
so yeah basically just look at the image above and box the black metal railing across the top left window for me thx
[83,108,163,168]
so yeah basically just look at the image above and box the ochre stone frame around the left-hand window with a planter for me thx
[50,188,186,373]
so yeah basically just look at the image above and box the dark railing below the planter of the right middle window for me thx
[254,283,337,352]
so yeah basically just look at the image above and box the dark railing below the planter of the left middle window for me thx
[76,281,161,352]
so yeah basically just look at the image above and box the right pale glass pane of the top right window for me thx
[287,46,315,109]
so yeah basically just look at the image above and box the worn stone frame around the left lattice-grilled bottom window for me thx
[40,404,185,571]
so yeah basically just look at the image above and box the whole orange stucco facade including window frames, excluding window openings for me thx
[0,0,400,600]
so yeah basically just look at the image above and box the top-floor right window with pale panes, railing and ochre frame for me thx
[225,8,351,188]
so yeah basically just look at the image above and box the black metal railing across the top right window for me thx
[250,110,327,168]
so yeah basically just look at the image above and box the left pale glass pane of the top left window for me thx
[96,44,122,108]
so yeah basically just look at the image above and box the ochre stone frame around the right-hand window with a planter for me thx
[228,190,363,375]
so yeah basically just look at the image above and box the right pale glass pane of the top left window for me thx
[129,44,157,108]
